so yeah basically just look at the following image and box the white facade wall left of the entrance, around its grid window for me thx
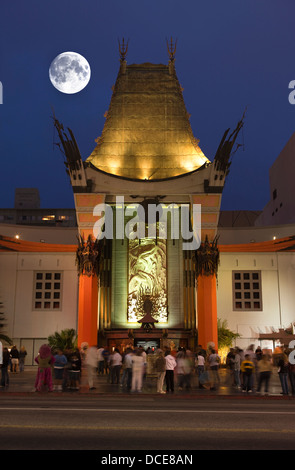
[0,252,78,362]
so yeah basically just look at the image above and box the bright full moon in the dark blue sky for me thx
[49,52,91,94]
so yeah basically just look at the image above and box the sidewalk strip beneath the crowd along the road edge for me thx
[0,366,295,399]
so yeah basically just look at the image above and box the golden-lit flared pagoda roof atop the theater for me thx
[86,61,210,180]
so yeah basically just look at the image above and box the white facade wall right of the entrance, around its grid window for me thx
[217,252,295,348]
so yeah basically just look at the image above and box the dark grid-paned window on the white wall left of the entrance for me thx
[33,271,62,310]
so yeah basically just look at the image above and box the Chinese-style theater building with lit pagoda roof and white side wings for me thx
[0,44,295,360]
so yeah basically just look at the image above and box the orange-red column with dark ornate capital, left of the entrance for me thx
[76,235,102,347]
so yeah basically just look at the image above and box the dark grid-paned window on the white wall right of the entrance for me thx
[232,271,262,311]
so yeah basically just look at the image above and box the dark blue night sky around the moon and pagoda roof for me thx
[0,0,295,210]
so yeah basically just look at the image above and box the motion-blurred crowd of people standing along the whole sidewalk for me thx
[1,344,295,395]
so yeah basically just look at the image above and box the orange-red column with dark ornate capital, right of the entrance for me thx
[195,236,219,349]
